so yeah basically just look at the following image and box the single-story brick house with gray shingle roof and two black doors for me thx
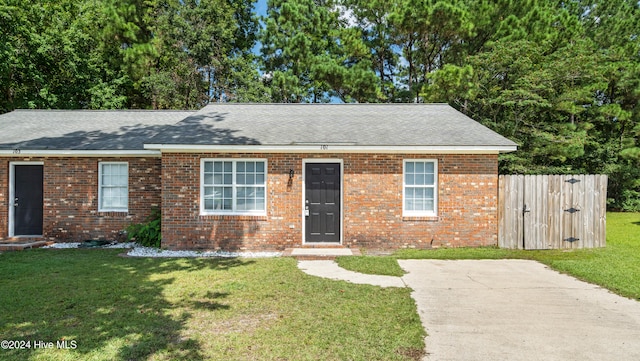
[0,104,516,250]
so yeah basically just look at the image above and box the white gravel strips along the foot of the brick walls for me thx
[42,242,282,258]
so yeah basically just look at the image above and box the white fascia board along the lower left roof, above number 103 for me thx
[0,149,162,157]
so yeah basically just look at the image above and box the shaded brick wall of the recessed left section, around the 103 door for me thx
[0,157,161,242]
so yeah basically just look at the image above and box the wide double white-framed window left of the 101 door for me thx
[200,159,267,215]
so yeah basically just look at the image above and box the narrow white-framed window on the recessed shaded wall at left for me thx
[98,162,129,212]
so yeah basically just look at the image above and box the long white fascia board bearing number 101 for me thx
[144,143,517,154]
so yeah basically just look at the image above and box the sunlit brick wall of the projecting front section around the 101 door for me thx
[162,153,498,250]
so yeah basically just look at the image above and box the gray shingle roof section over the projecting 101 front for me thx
[147,103,515,146]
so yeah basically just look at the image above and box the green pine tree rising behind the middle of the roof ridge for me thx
[262,0,380,102]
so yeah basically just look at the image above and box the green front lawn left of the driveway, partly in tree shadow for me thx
[0,249,425,360]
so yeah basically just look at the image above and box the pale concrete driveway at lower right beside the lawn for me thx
[399,260,640,361]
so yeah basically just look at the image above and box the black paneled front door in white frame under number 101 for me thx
[305,163,341,243]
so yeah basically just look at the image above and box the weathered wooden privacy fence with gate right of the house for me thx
[498,175,607,249]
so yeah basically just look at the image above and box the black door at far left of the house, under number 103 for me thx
[13,165,43,236]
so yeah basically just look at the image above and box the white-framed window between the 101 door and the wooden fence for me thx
[402,159,438,216]
